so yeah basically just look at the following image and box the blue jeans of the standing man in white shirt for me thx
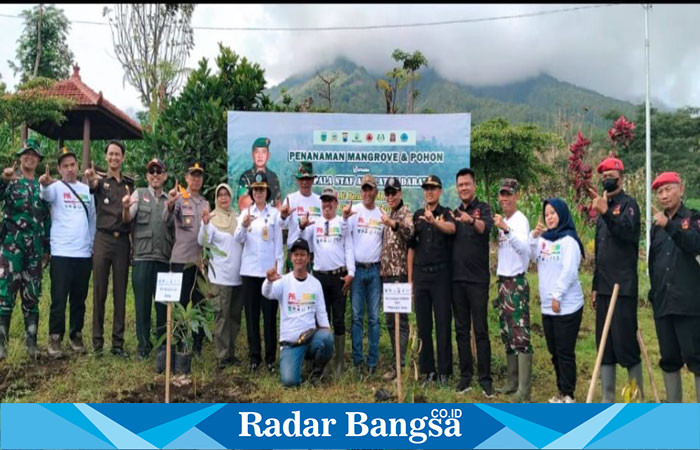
[352,264,382,367]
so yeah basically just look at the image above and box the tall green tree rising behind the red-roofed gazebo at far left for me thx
[8,4,73,83]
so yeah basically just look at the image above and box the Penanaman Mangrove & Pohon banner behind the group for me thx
[228,111,471,211]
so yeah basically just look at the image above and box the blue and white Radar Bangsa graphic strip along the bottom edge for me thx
[0,403,700,450]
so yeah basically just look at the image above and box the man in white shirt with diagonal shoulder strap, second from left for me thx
[39,147,96,358]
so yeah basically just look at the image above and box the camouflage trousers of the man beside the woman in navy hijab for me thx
[494,275,532,354]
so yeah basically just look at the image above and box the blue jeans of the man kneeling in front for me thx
[280,330,333,387]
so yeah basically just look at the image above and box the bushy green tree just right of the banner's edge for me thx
[471,117,557,203]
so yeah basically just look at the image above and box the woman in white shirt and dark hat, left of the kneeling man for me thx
[234,172,284,372]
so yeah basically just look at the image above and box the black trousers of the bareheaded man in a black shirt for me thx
[452,282,492,386]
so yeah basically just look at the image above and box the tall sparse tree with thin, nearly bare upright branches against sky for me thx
[103,3,194,123]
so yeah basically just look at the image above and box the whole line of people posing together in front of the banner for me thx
[0,138,700,403]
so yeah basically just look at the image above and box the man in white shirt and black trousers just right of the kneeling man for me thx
[300,187,355,378]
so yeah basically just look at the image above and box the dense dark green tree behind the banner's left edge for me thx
[148,43,274,201]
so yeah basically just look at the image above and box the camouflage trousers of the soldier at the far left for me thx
[0,233,43,316]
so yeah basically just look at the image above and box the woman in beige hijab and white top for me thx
[197,183,243,369]
